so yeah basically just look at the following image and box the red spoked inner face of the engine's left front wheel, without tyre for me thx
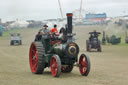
[50,57,58,76]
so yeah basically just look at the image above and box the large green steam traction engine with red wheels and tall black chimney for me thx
[29,13,90,77]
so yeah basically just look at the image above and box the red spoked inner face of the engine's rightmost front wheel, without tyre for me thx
[79,55,87,74]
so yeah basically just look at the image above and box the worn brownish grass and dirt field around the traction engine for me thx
[0,26,128,85]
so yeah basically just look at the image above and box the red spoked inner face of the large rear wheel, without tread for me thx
[29,44,38,72]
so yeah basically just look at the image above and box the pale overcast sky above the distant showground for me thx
[0,0,128,21]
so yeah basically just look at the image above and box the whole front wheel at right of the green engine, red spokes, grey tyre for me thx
[79,54,90,76]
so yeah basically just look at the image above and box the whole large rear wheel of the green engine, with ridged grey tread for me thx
[29,42,45,74]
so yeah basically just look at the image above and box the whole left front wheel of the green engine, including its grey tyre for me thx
[50,55,61,77]
